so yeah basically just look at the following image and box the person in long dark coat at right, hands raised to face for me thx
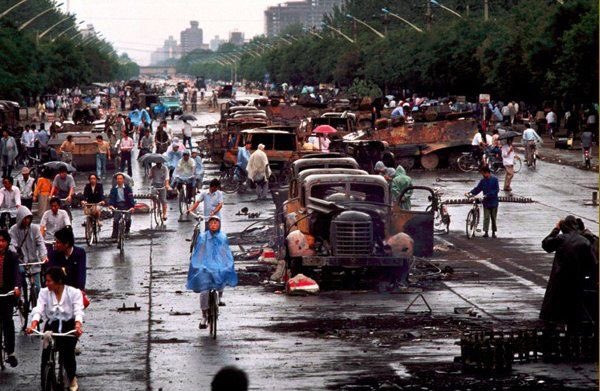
[540,216,598,326]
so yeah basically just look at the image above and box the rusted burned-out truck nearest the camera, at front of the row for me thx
[281,159,433,279]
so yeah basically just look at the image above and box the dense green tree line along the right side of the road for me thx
[180,0,599,102]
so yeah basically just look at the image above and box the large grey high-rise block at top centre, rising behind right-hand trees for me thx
[265,0,344,37]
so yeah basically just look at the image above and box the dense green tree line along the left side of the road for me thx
[0,0,139,101]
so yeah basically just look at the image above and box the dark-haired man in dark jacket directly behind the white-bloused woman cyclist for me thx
[48,227,87,290]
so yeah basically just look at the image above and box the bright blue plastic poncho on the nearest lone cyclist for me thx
[186,231,238,292]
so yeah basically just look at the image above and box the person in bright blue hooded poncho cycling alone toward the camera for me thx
[186,215,238,329]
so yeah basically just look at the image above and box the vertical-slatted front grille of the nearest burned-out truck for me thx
[332,221,373,256]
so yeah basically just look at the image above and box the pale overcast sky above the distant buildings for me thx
[63,0,285,65]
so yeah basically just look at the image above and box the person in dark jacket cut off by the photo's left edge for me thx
[0,230,21,367]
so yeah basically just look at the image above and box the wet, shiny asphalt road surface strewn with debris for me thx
[0,99,598,390]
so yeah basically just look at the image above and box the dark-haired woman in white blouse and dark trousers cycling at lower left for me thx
[27,267,83,391]
